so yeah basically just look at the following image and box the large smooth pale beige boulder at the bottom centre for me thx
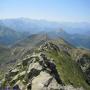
[32,71,60,90]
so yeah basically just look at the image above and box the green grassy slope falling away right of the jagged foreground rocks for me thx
[46,41,90,90]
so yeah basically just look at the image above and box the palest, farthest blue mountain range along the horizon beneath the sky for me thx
[0,18,90,34]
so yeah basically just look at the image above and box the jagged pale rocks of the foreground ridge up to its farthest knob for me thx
[0,43,90,90]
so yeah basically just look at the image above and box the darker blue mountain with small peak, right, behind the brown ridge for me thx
[48,29,90,49]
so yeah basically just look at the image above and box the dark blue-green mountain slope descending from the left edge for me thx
[0,25,27,45]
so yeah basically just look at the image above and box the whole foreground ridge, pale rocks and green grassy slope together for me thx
[1,36,90,90]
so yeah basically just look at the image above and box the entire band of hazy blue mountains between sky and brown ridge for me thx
[0,18,90,48]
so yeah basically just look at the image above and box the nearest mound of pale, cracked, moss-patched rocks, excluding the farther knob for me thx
[2,53,63,90]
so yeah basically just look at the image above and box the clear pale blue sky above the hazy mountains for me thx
[0,0,90,22]
